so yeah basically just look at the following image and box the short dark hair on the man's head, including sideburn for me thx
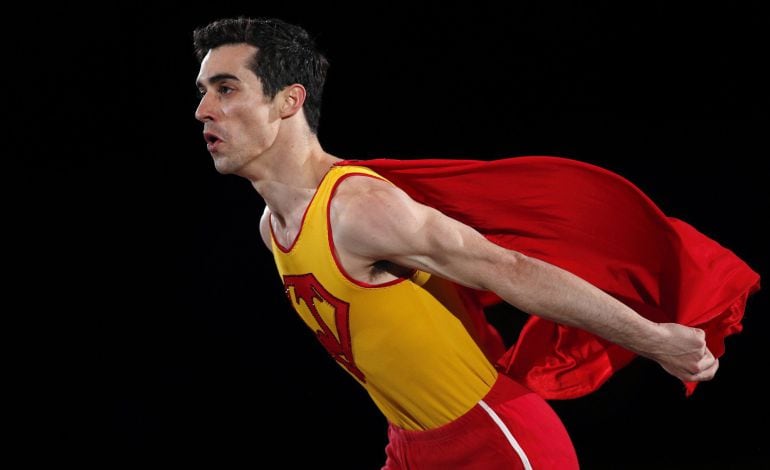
[193,18,329,133]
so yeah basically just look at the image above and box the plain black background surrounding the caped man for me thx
[21,2,770,469]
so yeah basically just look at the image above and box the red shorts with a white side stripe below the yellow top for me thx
[383,374,578,470]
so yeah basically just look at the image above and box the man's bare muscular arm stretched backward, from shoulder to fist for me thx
[332,177,718,381]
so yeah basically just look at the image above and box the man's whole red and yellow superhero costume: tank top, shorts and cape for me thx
[273,157,759,469]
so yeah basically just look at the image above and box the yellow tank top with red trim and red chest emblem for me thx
[271,166,497,430]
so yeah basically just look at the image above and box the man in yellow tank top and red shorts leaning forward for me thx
[190,19,757,469]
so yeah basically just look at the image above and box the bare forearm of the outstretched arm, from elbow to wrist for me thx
[489,252,665,357]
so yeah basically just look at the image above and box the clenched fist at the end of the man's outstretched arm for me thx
[649,323,719,382]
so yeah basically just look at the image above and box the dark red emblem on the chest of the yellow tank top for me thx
[283,274,366,382]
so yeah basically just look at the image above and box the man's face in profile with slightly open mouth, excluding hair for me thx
[195,44,280,174]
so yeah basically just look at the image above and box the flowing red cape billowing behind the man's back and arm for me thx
[340,157,759,399]
